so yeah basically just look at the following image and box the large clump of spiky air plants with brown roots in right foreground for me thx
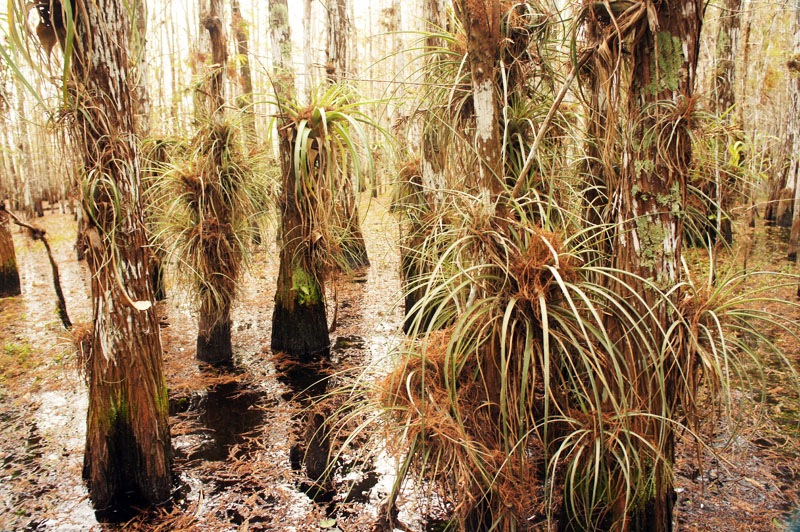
[366,182,789,530]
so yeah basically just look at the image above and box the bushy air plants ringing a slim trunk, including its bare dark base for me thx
[154,115,268,364]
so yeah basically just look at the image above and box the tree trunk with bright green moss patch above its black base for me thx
[269,0,330,357]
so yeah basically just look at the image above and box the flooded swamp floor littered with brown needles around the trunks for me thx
[0,199,800,532]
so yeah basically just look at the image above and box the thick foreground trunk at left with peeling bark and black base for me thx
[61,0,172,518]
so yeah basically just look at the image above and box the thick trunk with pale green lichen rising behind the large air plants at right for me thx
[613,5,703,532]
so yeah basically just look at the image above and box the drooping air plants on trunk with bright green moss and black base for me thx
[272,84,382,355]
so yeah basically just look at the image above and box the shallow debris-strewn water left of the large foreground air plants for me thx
[0,196,401,531]
